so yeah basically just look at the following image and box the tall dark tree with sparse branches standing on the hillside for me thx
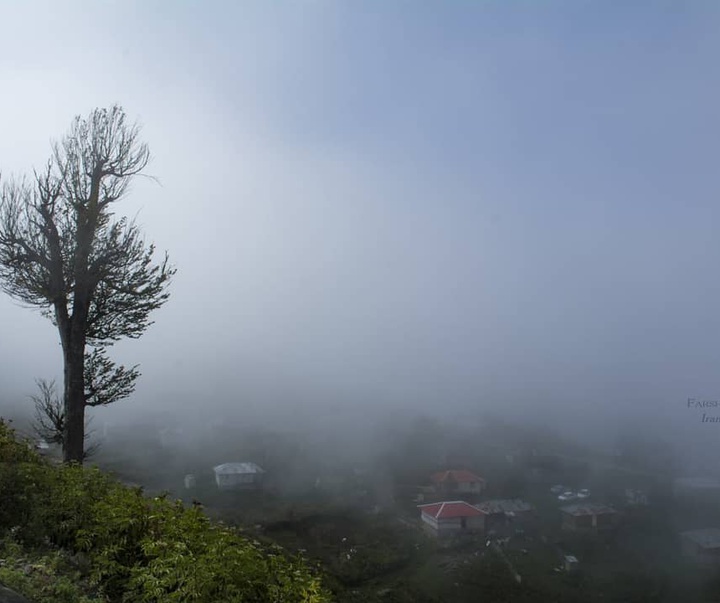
[0,105,175,462]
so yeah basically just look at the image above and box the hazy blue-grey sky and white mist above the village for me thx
[0,0,720,448]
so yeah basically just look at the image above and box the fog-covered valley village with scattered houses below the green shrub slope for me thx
[76,419,720,602]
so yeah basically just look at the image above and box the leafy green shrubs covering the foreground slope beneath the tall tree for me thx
[0,420,329,603]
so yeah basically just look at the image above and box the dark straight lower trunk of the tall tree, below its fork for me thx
[63,333,85,463]
